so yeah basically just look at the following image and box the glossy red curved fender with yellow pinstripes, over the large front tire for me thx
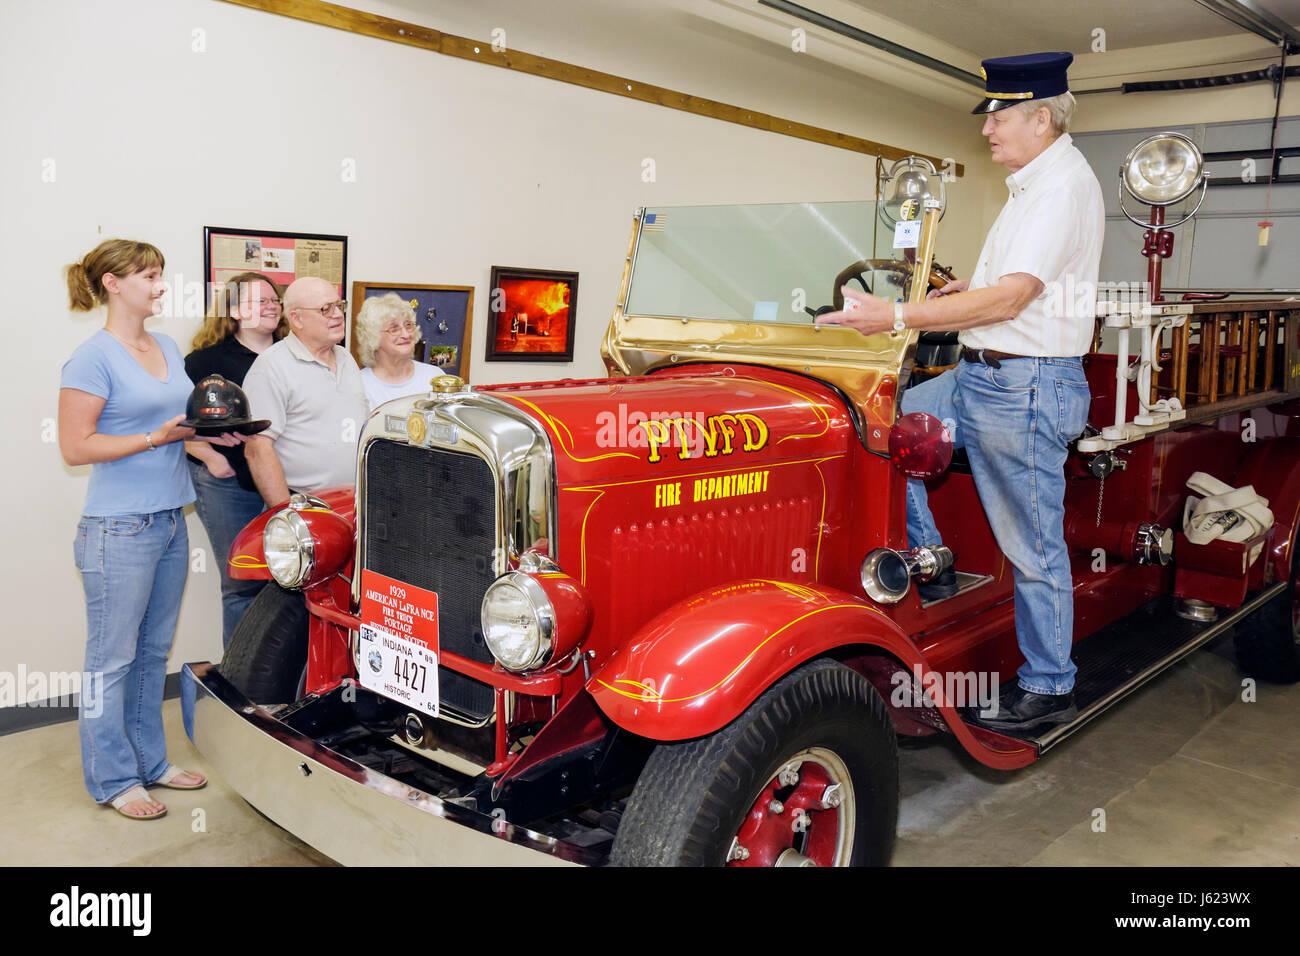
[586,580,924,740]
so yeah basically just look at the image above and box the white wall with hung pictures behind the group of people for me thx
[0,0,1002,672]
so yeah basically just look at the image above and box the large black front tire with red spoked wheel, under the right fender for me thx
[611,661,898,866]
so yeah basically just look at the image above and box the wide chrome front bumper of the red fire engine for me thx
[181,663,599,866]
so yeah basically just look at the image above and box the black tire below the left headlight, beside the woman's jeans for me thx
[217,581,311,705]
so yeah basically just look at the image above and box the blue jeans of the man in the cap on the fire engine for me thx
[902,358,1091,695]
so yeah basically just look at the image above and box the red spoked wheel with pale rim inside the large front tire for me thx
[727,747,857,866]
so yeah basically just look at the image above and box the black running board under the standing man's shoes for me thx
[967,581,1288,754]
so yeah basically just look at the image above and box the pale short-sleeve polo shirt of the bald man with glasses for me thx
[243,333,369,492]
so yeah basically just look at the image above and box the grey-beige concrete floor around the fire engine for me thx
[0,641,1300,866]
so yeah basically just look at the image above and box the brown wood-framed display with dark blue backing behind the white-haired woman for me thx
[347,282,475,381]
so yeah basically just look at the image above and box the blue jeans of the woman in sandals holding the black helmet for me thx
[74,509,190,803]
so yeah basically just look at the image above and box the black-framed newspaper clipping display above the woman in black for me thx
[203,226,347,303]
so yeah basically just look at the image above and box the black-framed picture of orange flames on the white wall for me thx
[484,265,577,362]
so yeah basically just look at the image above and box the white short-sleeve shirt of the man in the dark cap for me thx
[958,133,1106,358]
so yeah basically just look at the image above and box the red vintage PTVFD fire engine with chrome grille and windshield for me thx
[183,136,1300,866]
